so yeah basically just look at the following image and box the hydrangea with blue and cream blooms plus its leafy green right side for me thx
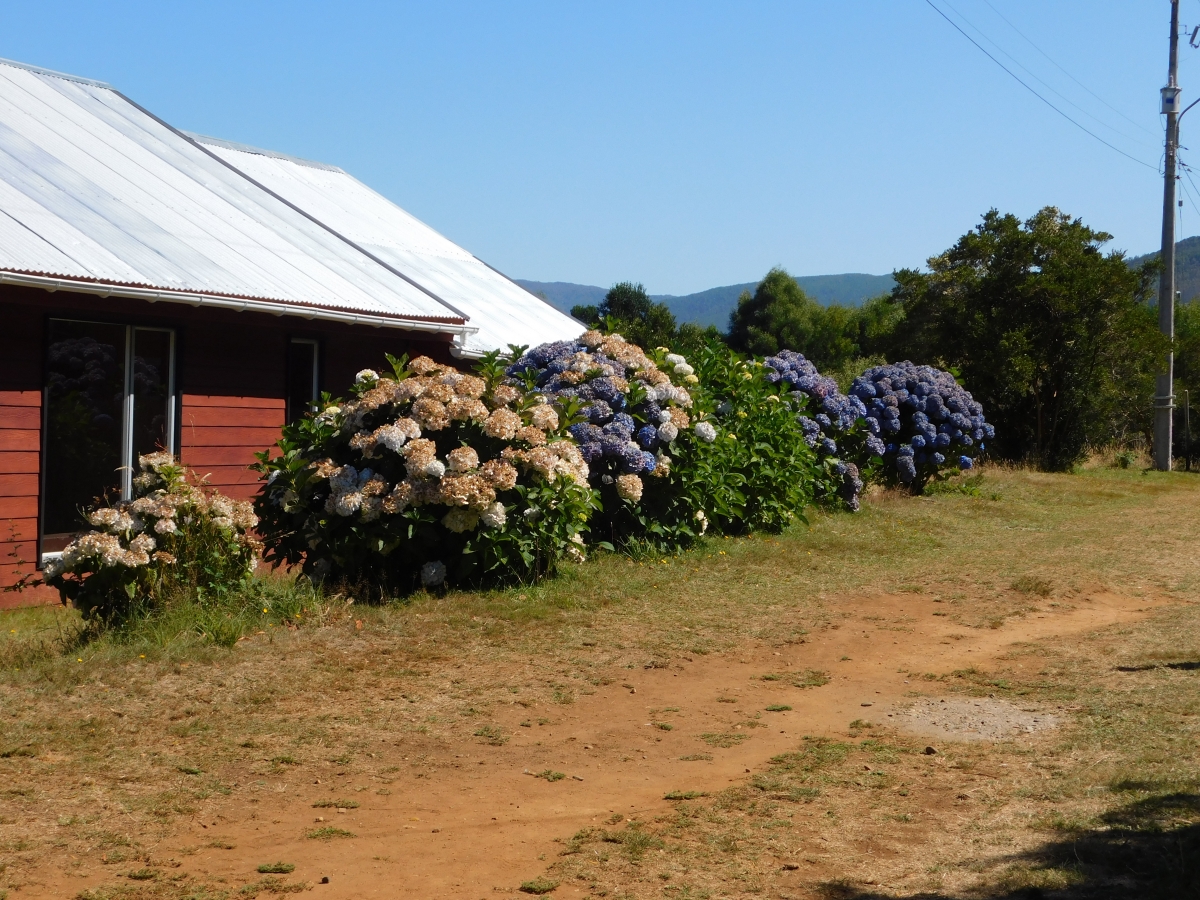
[508,331,841,550]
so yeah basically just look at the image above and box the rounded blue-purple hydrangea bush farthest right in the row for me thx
[850,361,996,493]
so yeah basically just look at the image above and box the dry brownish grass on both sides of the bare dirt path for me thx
[0,469,1200,900]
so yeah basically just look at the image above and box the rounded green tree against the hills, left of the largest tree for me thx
[728,268,863,371]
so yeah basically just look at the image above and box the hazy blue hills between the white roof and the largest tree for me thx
[514,272,895,331]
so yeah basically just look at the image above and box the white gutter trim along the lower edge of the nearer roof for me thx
[0,271,479,338]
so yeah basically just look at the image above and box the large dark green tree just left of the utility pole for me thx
[889,206,1165,469]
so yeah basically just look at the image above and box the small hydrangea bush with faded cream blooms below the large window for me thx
[42,452,262,623]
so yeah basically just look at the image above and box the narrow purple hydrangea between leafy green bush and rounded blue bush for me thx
[763,350,884,512]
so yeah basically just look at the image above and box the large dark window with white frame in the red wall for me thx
[41,319,175,552]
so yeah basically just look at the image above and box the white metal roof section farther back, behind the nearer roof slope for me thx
[191,134,583,355]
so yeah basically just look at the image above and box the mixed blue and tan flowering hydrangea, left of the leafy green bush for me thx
[506,331,718,546]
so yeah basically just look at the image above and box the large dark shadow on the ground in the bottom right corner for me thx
[823,796,1200,900]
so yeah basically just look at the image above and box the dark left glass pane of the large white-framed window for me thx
[42,320,125,540]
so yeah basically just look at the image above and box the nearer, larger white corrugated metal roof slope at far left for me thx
[0,61,469,331]
